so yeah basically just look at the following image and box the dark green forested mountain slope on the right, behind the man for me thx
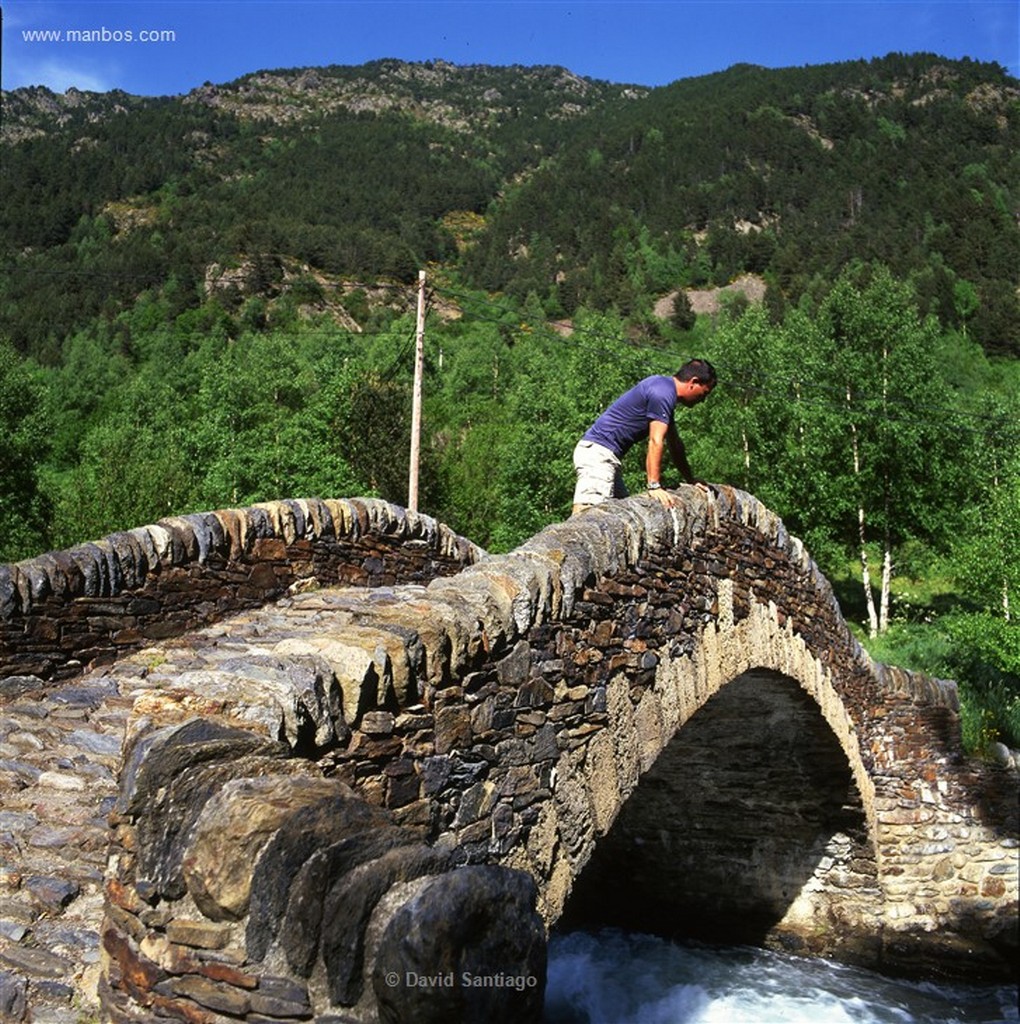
[468,55,1020,354]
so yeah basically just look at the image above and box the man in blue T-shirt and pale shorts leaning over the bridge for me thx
[572,359,716,515]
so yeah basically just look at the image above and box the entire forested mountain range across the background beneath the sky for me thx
[0,54,1020,362]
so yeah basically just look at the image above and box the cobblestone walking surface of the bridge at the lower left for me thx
[0,677,139,1024]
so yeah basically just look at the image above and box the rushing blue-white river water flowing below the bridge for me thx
[545,931,1020,1024]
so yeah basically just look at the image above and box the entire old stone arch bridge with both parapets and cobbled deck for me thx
[0,487,1017,1024]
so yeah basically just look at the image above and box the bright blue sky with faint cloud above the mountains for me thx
[0,0,1020,95]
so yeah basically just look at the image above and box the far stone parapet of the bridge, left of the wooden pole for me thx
[0,499,481,679]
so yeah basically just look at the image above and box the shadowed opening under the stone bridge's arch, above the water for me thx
[558,669,880,959]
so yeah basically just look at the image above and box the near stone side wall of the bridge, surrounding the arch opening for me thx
[91,490,1017,1021]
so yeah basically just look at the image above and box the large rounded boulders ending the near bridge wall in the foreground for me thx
[100,719,545,1024]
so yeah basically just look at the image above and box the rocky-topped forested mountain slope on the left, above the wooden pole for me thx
[0,60,643,361]
